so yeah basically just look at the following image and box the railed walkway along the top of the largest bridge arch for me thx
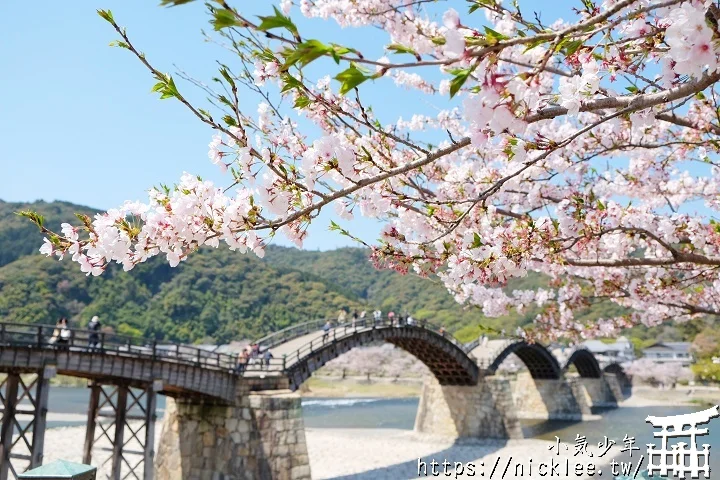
[240,317,465,373]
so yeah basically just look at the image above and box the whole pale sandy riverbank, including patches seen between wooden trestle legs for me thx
[40,421,604,480]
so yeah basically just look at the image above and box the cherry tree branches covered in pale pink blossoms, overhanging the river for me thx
[26,0,720,338]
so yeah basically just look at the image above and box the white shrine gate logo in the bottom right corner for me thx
[645,405,720,478]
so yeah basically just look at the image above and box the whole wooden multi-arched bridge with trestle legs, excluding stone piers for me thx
[0,318,622,480]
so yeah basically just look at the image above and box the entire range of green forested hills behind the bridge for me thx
[0,201,708,342]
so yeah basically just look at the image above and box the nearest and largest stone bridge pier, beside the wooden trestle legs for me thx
[155,378,311,480]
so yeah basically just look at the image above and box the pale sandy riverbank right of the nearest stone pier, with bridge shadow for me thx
[305,428,610,480]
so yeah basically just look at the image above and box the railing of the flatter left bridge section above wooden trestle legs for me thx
[0,323,237,370]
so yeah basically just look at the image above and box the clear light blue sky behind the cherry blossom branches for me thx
[0,0,584,249]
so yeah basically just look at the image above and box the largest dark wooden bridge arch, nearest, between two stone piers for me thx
[284,324,479,390]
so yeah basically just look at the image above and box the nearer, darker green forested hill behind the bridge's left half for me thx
[0,244,360,342]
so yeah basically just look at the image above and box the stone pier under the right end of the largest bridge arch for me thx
[415,376,522,438]
